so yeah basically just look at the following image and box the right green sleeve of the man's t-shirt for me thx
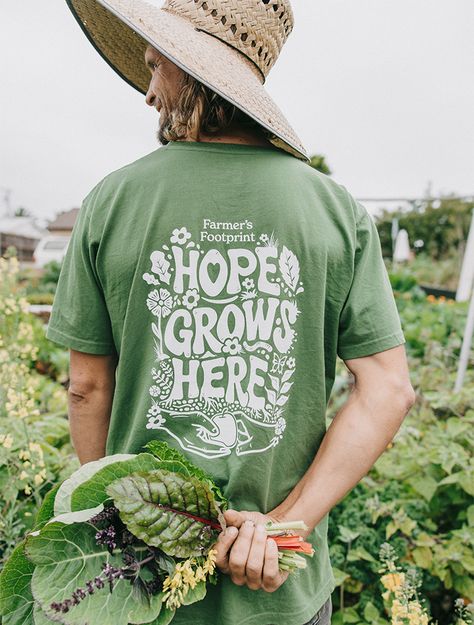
[337,202,406,360]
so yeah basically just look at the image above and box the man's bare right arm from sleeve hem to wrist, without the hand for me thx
[270,345,416,531]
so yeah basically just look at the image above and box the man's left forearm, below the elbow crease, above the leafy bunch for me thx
[68,389,113,464]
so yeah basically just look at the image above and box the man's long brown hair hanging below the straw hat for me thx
[158,73,273,145]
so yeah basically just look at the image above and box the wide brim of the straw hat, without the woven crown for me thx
[66,0,309,161]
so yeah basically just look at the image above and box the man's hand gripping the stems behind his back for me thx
[215,510,288,592]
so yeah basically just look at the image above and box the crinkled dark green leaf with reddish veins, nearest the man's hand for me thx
[107,469,220,558]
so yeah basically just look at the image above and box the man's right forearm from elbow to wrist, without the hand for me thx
[270,387,414,531]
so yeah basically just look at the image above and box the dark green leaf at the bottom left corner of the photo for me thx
[0,541,35,625]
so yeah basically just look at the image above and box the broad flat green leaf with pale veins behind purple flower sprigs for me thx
[26,523,161,625]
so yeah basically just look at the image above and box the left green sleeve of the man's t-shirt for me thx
[46,186,115,355]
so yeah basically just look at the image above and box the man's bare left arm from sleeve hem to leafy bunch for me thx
[68,349,117,464]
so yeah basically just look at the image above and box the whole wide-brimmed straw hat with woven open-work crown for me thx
[66,0,309,160]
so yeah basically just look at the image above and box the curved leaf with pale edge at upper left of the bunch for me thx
[54,454,159,515]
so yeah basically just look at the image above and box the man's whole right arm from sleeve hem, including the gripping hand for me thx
[217,345,415,591]
